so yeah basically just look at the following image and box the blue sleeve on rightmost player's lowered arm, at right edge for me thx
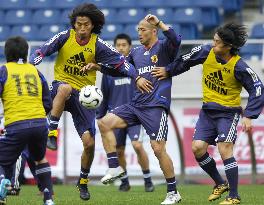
[235,59,264,119]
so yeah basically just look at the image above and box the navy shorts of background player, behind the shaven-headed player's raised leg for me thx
[114,125,143,146]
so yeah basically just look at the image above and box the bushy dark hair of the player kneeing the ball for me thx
[69,3,105,34]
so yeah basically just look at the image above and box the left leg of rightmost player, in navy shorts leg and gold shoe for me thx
[192,110,229,201]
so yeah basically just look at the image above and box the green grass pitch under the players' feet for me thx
[7,184,264,205]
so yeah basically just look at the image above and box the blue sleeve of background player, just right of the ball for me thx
[96,75,109,119]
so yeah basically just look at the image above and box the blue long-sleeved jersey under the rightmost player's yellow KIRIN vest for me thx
[166,45,264,119]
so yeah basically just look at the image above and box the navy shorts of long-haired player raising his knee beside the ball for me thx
[50,81,95,137]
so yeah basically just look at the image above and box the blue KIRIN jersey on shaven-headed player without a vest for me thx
[127,28,181,110]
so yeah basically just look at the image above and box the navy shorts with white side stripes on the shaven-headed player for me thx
[111,103,168,141]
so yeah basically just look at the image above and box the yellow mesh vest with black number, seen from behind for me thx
[2,63,46,126]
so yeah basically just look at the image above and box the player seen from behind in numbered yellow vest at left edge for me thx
[0,37,54,205]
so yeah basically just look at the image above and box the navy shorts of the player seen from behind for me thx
[0,119,48,166]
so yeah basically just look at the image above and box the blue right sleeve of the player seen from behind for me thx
[38,71,52,114]
